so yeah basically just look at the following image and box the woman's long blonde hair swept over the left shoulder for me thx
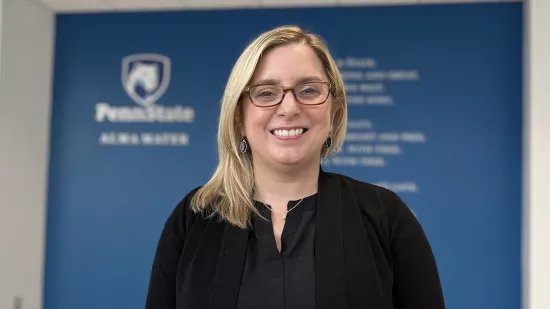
[191,26,347,228]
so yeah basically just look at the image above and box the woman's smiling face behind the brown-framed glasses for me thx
[239,44,332,166]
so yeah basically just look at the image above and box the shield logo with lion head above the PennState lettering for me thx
[122,54,170,107]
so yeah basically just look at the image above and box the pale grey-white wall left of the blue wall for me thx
[0,0,54,309]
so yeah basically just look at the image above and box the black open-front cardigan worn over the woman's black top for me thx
[146,170,445,309]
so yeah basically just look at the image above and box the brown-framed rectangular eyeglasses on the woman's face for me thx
[244,81,332,107]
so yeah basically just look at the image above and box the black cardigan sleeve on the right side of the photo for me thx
[389,194,445,309]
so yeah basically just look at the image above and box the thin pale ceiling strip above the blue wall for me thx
[31,0,521,12]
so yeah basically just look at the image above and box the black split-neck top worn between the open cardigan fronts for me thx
[236,194,317,309]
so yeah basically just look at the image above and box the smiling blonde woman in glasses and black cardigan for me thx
[146,26,444,309]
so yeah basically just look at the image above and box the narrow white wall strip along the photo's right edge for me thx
[524,0,550,309]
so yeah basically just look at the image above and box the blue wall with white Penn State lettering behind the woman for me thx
[44,3,522,309]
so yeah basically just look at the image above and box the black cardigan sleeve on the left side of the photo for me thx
[145,189,196,309]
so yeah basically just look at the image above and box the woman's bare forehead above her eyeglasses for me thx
[252,44,325,84]
